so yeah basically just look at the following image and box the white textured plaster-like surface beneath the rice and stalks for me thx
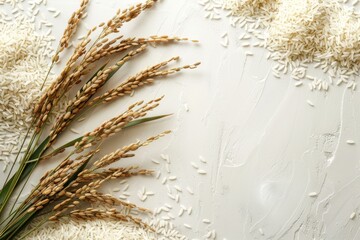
[15,0,360,240]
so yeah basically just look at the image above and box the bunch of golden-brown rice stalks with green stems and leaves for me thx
[0,0,200,240]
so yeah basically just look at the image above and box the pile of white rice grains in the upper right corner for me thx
[200,0,360,91]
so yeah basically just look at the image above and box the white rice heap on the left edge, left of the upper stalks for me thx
[0,18,53,170]
